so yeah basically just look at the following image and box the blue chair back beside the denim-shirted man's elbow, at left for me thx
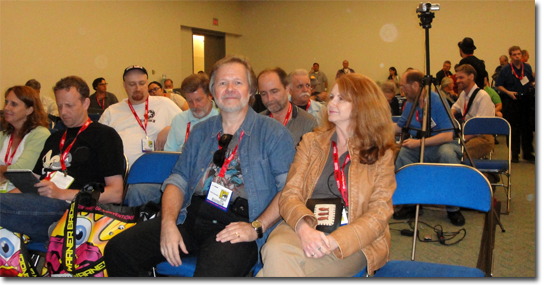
[127,151,180,184]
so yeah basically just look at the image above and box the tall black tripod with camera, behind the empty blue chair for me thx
[400,3,505,260]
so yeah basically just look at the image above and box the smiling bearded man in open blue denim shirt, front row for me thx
[105,57,295,276]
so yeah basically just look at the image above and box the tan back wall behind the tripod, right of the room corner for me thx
[242,0,536,84]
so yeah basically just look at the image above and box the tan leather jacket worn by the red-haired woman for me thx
[279,129,397,273]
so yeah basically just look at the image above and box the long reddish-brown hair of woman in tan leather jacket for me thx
[316,73,395,165]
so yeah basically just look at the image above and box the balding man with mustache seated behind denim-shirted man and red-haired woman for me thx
[257,67,317,147]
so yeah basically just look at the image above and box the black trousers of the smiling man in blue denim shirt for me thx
[104,196,258,277]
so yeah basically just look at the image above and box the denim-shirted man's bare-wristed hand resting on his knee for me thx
[161,220,189,267]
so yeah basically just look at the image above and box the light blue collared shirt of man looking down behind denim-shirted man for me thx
[164,102,219,152]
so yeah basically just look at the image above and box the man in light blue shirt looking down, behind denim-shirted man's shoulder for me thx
[164,74,219,152]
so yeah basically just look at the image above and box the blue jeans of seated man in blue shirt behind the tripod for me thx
[395,140,463,212]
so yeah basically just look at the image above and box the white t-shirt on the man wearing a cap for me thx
[98,96,182,166]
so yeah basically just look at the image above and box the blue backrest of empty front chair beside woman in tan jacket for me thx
[393,163,492,212]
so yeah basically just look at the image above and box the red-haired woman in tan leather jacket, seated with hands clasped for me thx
[259,74,396,276]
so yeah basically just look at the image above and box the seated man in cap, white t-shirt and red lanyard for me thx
[99,65,182,206]
